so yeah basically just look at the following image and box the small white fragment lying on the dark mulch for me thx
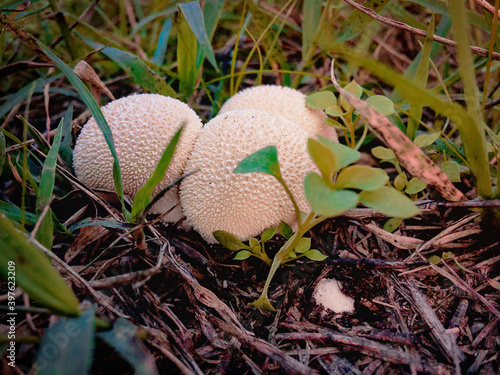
[313,279,354,314]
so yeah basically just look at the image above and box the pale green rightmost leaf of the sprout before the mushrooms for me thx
[359,186,420,219]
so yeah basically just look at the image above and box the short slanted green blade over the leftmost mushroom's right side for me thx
[131,125,184,223]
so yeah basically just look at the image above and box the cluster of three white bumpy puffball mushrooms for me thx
[74,85,337,243]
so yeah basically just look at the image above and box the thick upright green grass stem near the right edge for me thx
[448,0,493,197]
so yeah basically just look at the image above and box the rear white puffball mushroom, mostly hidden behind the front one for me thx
[219,85,338,141]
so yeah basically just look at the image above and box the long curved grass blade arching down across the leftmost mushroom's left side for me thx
[38,42,128,216]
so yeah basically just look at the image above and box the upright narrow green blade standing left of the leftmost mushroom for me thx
[36,120,63,249]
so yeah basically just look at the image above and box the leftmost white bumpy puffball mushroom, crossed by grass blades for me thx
[73,94,202,221]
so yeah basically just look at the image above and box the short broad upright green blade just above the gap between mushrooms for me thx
[176,6,198,97]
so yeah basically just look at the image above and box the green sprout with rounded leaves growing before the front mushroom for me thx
[214,136,419,311]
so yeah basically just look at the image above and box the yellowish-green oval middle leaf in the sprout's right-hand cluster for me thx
[335,165,389,190]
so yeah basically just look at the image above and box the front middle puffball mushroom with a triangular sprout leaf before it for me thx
[180,110,316,243]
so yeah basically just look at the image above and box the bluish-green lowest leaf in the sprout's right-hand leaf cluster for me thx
[304,173,358,217]
